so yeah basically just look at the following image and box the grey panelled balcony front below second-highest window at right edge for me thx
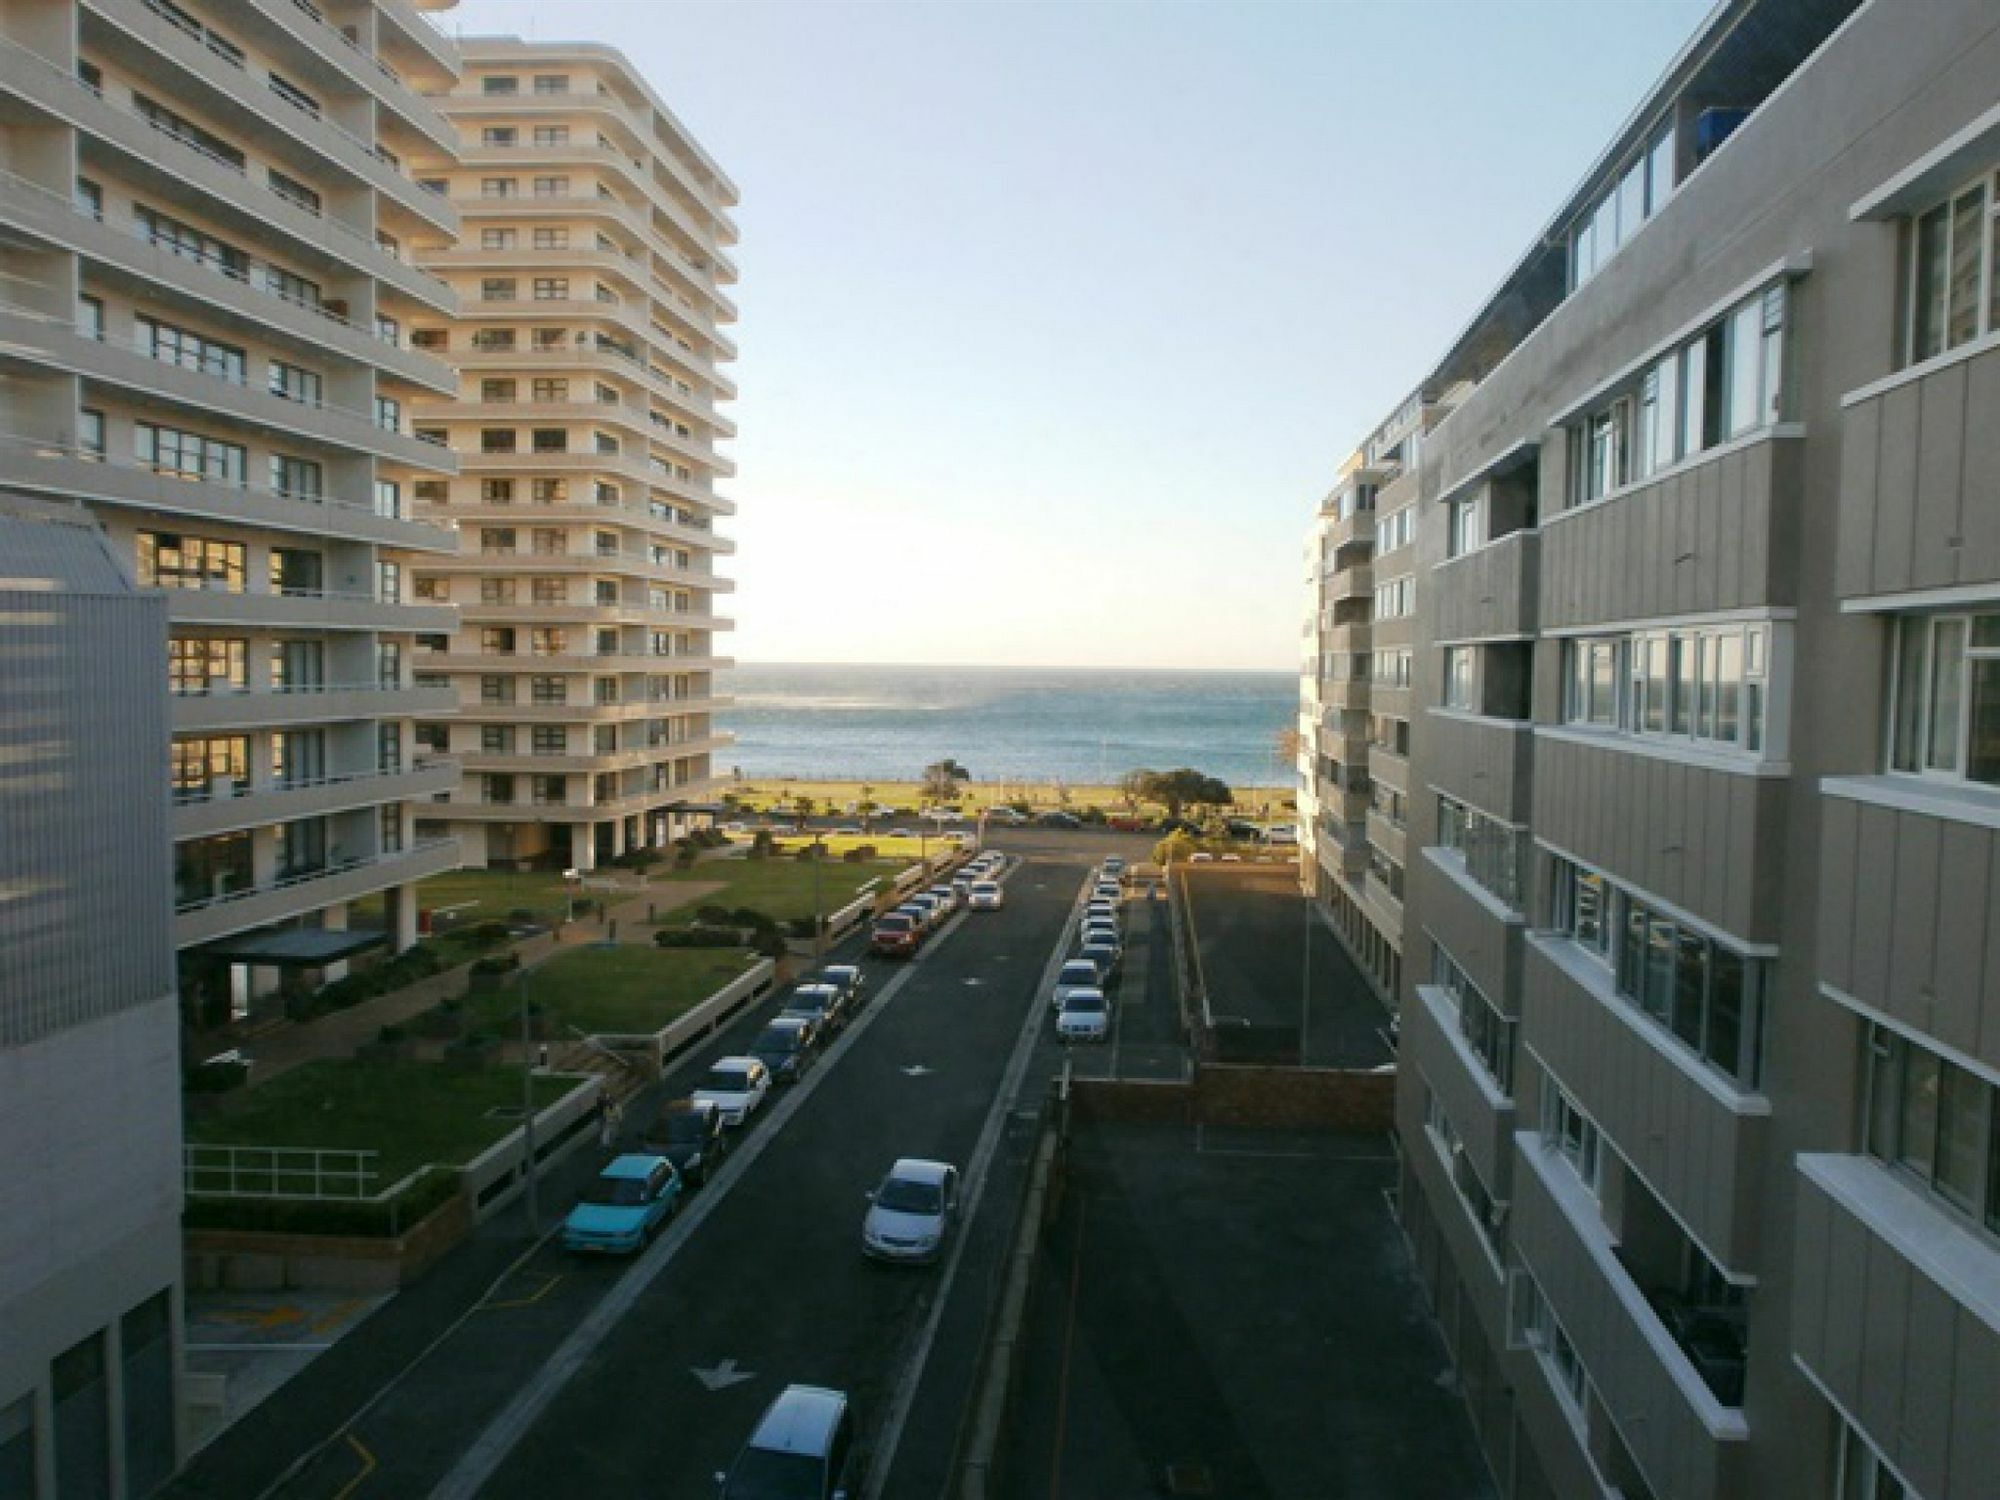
[1818,776,2000,1058]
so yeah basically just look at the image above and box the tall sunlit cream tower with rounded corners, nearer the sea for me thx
[402,38,736,868]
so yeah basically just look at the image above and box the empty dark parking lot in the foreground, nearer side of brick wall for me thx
[1002,1122,1492,1500]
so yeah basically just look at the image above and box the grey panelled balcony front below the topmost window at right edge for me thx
[1834,338,2000,600]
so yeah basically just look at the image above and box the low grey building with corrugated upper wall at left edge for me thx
[0,498,180,1500]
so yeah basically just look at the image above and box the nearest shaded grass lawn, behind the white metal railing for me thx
[188,1058,576,1192]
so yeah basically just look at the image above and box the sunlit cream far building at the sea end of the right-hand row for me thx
[1298,392,1448,1008]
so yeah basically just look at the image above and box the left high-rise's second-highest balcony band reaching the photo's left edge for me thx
[0,167,458,394]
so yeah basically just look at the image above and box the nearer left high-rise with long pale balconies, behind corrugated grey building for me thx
[0,0,458,1016]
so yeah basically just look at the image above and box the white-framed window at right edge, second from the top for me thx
[1890,612,2000,786]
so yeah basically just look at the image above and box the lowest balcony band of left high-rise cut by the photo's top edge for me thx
[84,0,458,238]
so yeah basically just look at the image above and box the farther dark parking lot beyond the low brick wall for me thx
[1182,864,1394,1068]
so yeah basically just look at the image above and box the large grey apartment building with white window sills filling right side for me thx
[1296,0,2000,1500]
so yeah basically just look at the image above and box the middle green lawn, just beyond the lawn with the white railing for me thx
[468,944,756,1036]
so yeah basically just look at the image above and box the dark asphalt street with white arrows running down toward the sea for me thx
[174,830,1178,1500]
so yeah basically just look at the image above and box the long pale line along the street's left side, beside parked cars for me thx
[430,918,936,1500]
